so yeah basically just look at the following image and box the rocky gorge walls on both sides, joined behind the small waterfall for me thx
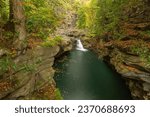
[0,0,150,100]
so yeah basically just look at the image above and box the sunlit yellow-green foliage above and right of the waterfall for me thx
[78,0,128,37]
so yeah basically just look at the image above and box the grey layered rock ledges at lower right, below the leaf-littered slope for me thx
[105,48,150,99]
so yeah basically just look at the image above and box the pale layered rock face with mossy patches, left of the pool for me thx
[0,40,72,99]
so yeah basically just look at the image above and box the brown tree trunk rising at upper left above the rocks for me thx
[9,0,26,51]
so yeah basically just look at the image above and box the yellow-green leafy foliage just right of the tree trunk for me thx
[25,0,59,39]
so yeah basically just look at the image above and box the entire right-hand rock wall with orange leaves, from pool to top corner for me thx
[89,0,150,99]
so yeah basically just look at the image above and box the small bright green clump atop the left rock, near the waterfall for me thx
[42,36,62,47]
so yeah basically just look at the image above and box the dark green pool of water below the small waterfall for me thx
[54,50,131,100]
